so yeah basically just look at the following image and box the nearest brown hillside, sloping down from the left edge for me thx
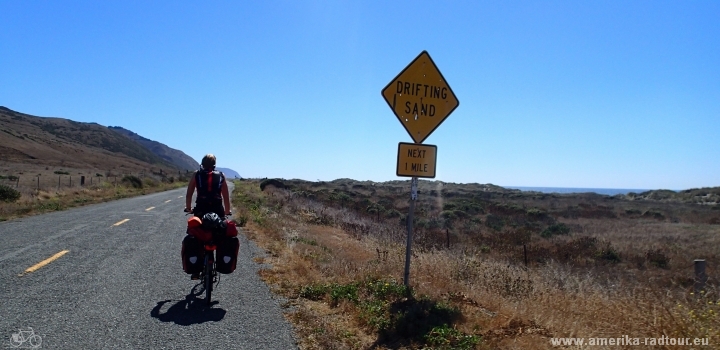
[0,107,176,170]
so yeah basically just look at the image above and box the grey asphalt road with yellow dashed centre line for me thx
[0,185,297,349]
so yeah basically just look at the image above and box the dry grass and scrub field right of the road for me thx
[233,179,720,349]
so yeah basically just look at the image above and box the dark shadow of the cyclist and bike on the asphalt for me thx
[150,286,226,326]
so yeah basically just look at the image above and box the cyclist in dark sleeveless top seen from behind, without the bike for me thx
[185,154,231,217]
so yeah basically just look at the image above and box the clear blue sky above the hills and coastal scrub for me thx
[0,0,720,189]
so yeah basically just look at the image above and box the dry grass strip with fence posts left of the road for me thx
[0,169,189,221]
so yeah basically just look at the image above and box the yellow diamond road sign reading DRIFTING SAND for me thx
[382,51,460,143]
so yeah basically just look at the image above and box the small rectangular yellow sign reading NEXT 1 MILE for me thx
[395,142,437,178]
